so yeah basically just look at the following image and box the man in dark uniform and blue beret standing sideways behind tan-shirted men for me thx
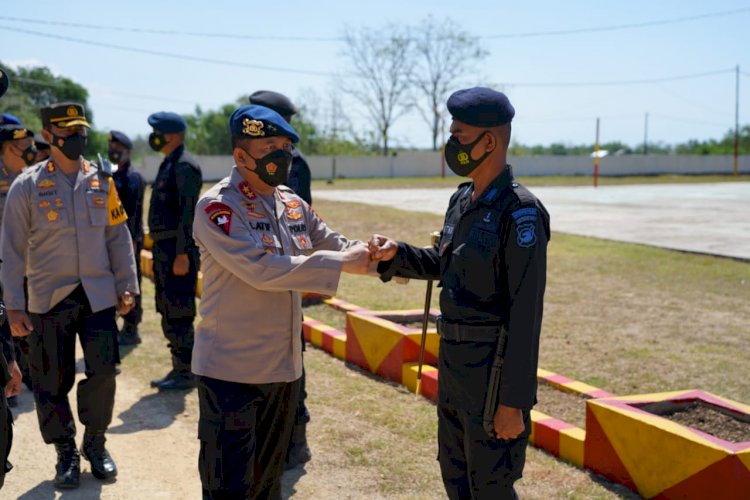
[148,111,203,390]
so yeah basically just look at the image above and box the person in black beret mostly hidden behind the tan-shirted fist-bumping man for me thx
[250,90,312,469]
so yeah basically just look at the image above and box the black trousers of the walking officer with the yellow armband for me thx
[28,286,117,444]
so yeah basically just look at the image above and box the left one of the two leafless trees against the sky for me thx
[341,25,414,155]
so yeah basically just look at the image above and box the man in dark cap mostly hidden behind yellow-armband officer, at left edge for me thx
[0,125,37,408]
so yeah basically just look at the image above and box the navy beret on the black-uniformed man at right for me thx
[448,87,516,127]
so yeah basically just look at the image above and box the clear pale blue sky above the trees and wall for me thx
[0,0,750,147]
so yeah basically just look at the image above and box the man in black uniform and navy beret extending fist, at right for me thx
[370,87,550,499]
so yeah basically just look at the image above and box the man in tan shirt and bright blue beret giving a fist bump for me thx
[192,105,370,499]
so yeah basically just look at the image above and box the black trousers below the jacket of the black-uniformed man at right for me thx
[437,405,531,500]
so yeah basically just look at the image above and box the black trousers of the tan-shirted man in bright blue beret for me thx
[198,377,299,500]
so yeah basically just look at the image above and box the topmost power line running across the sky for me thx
[0,7,750,42]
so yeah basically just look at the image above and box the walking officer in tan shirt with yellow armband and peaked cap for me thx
[0,103,139,488]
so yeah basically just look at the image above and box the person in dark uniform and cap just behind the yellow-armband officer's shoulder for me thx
[107,130,146,345]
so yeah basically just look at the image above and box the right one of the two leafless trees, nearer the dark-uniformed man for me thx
[411,17,487,151]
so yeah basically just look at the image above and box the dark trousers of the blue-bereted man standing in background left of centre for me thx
[152,238,198,374]
